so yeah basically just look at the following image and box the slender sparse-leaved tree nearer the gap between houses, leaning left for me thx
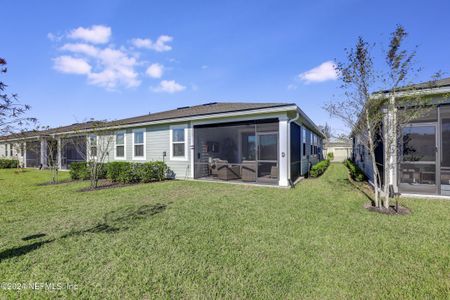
[324,37,383,207]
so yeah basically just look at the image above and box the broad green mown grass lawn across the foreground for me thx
[0,164,450,299]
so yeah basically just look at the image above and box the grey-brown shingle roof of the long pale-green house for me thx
[0,102,296,140]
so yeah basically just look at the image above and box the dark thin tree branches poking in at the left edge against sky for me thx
[0,57,37,135]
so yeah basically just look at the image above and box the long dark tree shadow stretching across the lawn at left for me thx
[0,203,167,262]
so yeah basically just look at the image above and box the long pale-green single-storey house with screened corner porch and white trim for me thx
[0,102,324,186]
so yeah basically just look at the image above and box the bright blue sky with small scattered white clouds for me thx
[0,0,450,134]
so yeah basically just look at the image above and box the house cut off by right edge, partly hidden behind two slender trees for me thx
[353,78,450,196]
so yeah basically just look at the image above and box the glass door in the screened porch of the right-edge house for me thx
[399,123,437,194]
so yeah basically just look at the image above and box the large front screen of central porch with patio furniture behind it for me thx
[194,119,279,184]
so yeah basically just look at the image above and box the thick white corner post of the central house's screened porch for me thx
[278,116,289,186]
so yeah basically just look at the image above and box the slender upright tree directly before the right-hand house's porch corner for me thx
[378,25,441,208]
